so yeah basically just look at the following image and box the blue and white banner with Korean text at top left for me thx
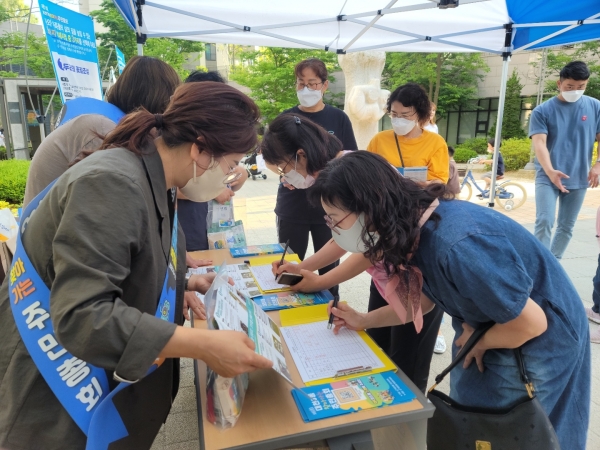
[39,0,102,103]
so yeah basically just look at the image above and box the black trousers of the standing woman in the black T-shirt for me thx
[277,217,338,301]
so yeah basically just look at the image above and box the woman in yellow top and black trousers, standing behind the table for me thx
[367,83,450,391]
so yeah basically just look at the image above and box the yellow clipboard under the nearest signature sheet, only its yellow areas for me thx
[279,305,398,386]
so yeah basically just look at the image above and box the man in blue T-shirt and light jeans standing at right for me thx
[529,61,600,259]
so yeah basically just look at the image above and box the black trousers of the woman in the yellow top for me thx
[367,281,444,393]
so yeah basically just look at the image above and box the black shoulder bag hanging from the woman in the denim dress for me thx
[427,323,560,450]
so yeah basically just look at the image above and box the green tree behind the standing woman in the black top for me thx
[231,47,339,123]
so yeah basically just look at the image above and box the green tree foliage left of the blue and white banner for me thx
[0,31,54,78]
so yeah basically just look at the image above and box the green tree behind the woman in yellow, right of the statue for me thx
[383,53,489,116]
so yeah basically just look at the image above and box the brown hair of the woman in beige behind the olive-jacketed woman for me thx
[106,56,181,114]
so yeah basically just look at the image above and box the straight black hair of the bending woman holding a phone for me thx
[260,114,343,174]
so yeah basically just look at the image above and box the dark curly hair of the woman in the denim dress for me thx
[306,151,446,275]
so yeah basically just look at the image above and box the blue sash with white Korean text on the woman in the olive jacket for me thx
[8,182,177,450]
